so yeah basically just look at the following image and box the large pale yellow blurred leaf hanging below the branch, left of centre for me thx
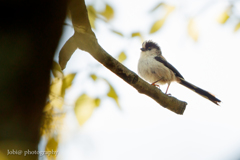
[74,94,100,125]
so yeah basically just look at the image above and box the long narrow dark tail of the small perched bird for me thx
[179,78,221,105]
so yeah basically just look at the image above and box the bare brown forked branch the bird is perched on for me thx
[59,0,187,114]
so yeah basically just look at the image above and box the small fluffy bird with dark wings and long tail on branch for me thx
[138,40,221,105]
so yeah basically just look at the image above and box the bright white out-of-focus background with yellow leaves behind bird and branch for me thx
[42,0,240,160]
